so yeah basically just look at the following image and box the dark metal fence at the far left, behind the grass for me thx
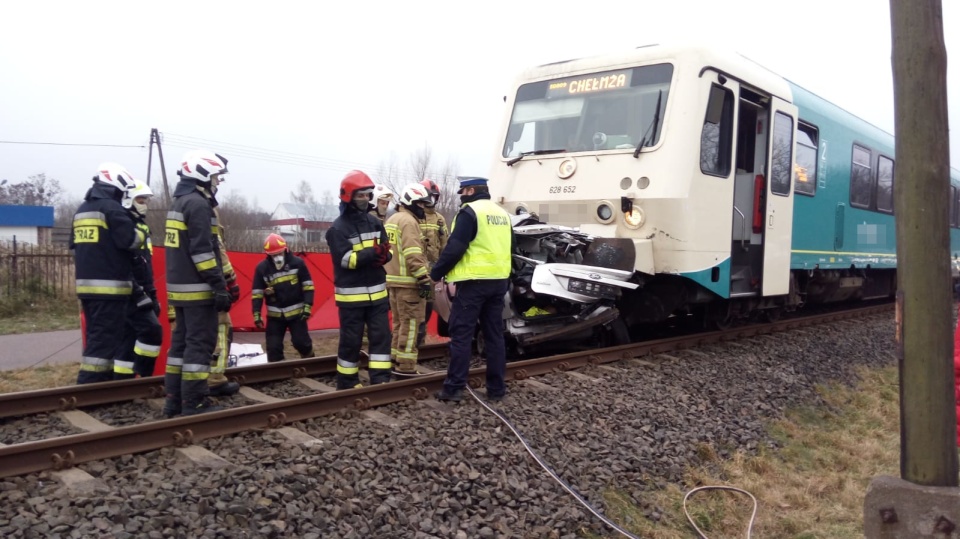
[0,237,76,300]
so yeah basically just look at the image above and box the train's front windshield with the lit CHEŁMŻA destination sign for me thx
[503,64,673,157]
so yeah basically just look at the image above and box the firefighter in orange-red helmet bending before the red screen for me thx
[253,234,313,362]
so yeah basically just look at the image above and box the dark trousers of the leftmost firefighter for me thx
[77,296,130,384]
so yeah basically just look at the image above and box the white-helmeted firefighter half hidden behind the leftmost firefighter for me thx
[113,180,163,379]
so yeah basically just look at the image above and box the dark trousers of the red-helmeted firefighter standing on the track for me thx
[337,301,393,389]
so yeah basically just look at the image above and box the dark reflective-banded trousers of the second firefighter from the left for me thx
[113,300,163,380]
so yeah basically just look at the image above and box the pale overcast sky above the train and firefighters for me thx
[0,0,960,215]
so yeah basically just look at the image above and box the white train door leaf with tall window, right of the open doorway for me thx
[761,97,797,296]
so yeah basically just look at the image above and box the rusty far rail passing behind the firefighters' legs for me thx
[0,344,447,419]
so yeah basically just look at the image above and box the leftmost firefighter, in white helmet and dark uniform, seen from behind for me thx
[70,163,147,384]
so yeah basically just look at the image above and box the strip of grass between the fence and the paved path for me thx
[0,293,80,335]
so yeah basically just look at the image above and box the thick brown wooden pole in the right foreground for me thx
[890,0,958,487]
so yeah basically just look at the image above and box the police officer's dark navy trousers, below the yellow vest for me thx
[443,279,507,396]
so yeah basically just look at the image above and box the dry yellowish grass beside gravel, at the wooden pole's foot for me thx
[587,367,900,539]
